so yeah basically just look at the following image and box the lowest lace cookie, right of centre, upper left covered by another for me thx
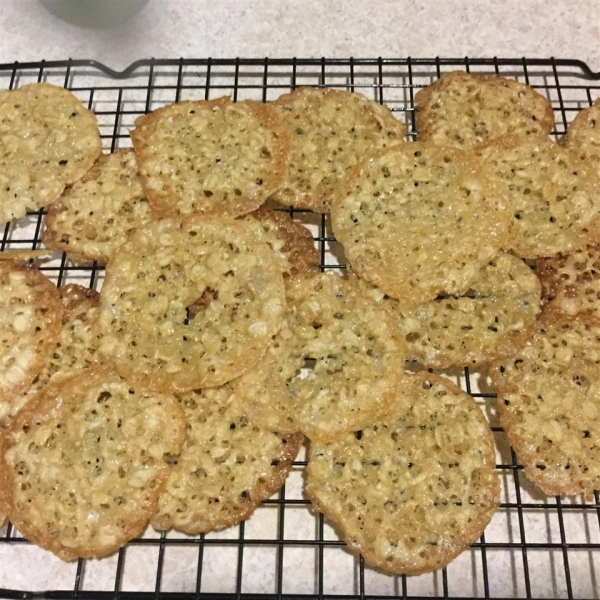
[306,373,500,575]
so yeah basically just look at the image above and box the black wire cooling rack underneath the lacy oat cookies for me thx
[0,58,600,600]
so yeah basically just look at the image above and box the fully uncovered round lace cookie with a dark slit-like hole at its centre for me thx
[98,217,285,393]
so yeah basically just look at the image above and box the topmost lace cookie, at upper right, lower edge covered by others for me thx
[415,71,554,150]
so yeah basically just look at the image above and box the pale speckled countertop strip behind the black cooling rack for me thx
[0,0,600,70]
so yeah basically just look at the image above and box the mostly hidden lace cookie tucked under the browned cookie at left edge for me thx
[0,284,100,425]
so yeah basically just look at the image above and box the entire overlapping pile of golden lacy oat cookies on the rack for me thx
[0,73,600,574]
